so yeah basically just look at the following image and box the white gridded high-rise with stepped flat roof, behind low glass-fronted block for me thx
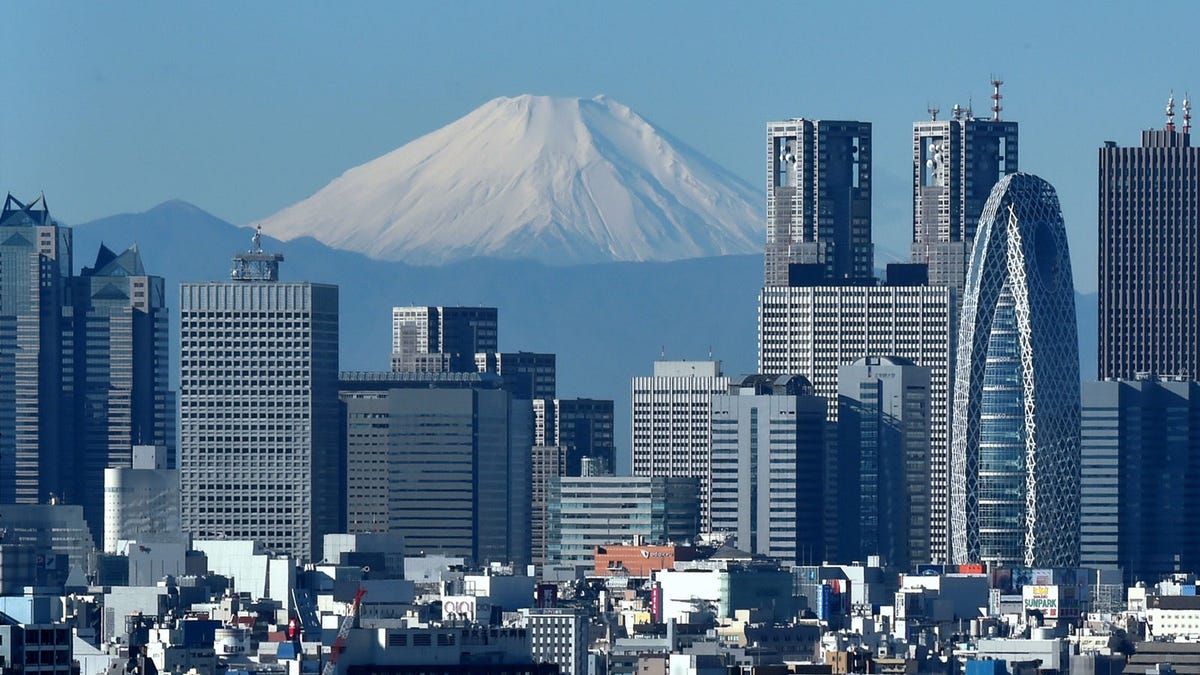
[631,362,730,532]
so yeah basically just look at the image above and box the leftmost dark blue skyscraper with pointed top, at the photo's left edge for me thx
[0,195,72,504]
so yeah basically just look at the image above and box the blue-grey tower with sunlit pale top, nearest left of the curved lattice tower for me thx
[836,357,932,569]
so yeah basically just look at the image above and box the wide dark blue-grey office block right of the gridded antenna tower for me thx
[340,372,533,567]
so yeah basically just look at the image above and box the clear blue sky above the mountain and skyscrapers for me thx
[0,1,1200,291]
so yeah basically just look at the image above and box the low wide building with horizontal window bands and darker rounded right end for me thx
[546,476,700,574]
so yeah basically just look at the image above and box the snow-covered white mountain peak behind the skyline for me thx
[262,95,766,264]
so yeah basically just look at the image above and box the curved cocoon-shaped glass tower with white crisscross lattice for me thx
[950,173,1079,567]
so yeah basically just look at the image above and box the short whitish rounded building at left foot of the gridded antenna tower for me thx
[103,446,184,554]
